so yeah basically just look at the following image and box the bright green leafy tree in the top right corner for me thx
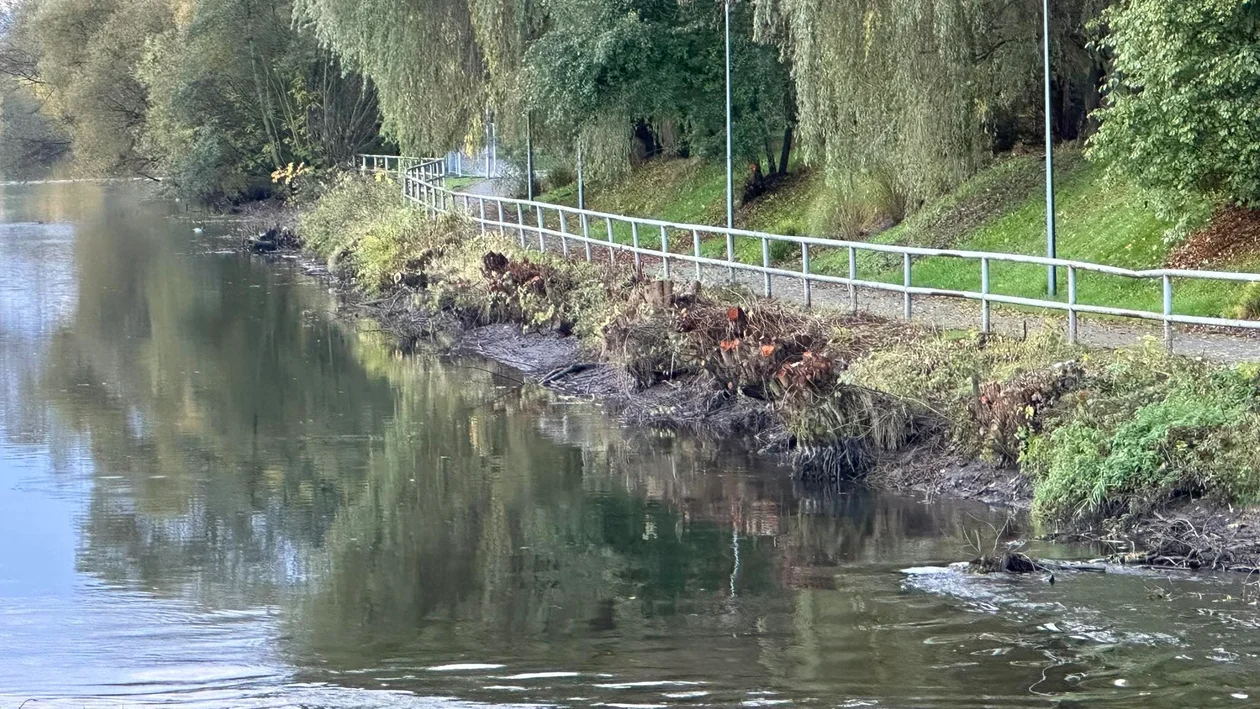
[1090,0,1260,212]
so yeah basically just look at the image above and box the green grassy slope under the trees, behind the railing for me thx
[543,147,1260,315]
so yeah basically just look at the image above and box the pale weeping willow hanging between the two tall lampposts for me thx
[757,0,1097,200]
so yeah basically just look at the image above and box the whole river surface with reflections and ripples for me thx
[0,183,1260,708]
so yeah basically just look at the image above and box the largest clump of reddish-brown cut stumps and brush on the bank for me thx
[604,281,925,482]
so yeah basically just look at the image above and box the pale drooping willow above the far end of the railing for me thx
[297,0,542,154]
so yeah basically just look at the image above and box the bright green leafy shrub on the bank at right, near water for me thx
[1023,348,1260,520]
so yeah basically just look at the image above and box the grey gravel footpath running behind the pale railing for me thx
[461,180,1260,363]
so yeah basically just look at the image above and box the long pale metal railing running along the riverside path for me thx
[359,155,1260,348]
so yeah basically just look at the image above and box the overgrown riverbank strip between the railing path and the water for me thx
[278,179,1260,567]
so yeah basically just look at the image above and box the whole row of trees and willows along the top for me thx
[0,0,1260,219]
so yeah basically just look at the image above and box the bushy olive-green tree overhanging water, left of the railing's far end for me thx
[137,0,379,201]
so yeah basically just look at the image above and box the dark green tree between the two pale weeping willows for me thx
[524,0,795,186]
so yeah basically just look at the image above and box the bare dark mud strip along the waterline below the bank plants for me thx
[342,266,1260,570]
